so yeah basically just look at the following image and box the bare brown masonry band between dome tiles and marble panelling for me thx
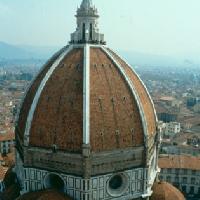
[21,145,145,176]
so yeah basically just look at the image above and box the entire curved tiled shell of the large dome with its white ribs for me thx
[16,45,156,153]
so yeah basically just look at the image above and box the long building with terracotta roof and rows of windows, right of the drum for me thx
[159,155,200,198]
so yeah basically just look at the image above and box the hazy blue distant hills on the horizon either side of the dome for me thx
[0,41,200,67]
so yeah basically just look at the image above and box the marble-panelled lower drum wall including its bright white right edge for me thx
[15,145,158,200]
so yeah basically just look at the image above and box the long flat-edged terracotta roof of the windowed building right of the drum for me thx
[158,155,200,170]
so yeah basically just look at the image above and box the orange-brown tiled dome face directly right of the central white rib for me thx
[90,48,144,152]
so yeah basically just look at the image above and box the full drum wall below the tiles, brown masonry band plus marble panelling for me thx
[15,132,158,200]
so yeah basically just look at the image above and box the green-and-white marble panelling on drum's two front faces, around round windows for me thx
[23,168,147,200]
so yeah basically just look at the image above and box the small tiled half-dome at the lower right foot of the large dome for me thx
[150,182,185,200]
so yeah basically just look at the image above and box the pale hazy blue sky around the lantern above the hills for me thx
[0,0,200,55]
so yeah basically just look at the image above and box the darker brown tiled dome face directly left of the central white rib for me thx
[30,49,83,152]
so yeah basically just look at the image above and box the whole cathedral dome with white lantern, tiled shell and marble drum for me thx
[1,0,184,200]
